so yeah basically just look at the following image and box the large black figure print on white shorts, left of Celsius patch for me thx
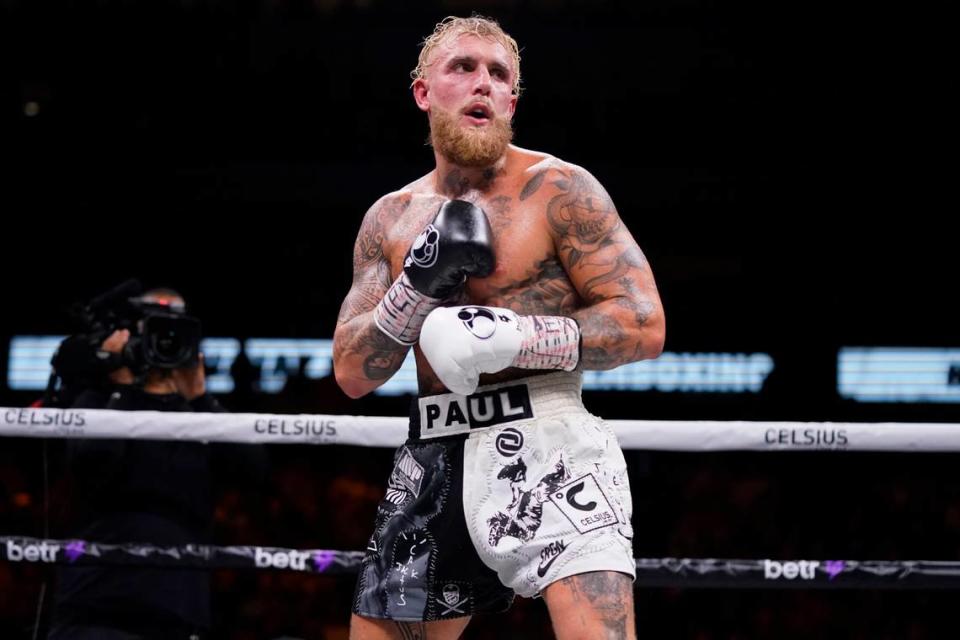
[487,455,570,547]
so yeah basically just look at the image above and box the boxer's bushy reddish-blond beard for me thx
[430,108,513,168]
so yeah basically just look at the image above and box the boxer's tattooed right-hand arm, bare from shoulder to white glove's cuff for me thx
[547,165,664,369]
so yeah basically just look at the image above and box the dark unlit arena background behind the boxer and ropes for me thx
[0,0,960,638]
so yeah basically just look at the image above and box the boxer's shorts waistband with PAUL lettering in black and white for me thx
[409,371,586,440]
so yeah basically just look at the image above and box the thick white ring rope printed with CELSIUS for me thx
[0,407,960,452]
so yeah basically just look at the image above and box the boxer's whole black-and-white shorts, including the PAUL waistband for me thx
[353,372,636,620]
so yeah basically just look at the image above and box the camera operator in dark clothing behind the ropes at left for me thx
[47,289,229,640]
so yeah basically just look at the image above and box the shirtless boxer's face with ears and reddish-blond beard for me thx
[413,34,517,167]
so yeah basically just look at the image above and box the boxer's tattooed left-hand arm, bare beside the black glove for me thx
[333,195,410,398]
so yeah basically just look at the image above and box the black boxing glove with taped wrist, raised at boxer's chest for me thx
[373,200,494,345]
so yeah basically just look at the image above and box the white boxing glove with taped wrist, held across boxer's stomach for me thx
[420,306,580,395]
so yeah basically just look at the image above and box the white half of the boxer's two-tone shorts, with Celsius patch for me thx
[463,372,636,596]
